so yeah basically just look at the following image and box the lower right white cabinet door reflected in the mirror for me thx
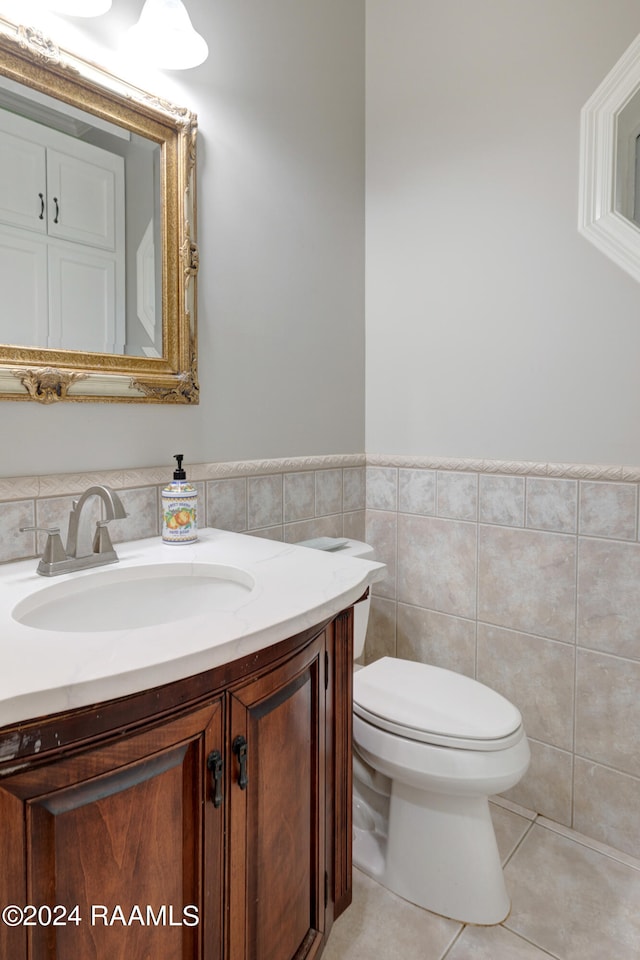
[47,243,124,353]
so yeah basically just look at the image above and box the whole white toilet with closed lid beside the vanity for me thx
[346,541,530,924]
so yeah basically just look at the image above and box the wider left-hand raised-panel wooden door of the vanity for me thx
[0,700,224,960]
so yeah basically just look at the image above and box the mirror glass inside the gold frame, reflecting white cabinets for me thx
[0,77,162,357]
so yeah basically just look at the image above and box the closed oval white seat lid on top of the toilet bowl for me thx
[353,657,522,740]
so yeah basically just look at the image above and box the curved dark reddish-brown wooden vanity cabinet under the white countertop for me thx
[0,611,352,960]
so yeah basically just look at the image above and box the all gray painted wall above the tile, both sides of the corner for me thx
[7,0,640,476]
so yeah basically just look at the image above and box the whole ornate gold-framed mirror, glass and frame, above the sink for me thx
[0,17,198,404]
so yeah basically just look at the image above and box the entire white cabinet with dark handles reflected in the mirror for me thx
[0,110,125,353]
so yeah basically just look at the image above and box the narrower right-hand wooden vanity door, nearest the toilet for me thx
[228,632,325,960]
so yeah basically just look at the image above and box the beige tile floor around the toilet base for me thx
[323,801,640,960]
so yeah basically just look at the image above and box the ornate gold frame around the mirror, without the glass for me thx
[0,17,199,404]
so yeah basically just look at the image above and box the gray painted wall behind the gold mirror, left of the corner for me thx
[0,0,364,476]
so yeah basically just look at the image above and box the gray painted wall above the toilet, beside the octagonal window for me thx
[366,0,640,464]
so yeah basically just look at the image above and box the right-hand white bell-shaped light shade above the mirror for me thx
[124,0,209,70]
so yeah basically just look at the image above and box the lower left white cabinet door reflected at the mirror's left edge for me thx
[0,227,49,347]
